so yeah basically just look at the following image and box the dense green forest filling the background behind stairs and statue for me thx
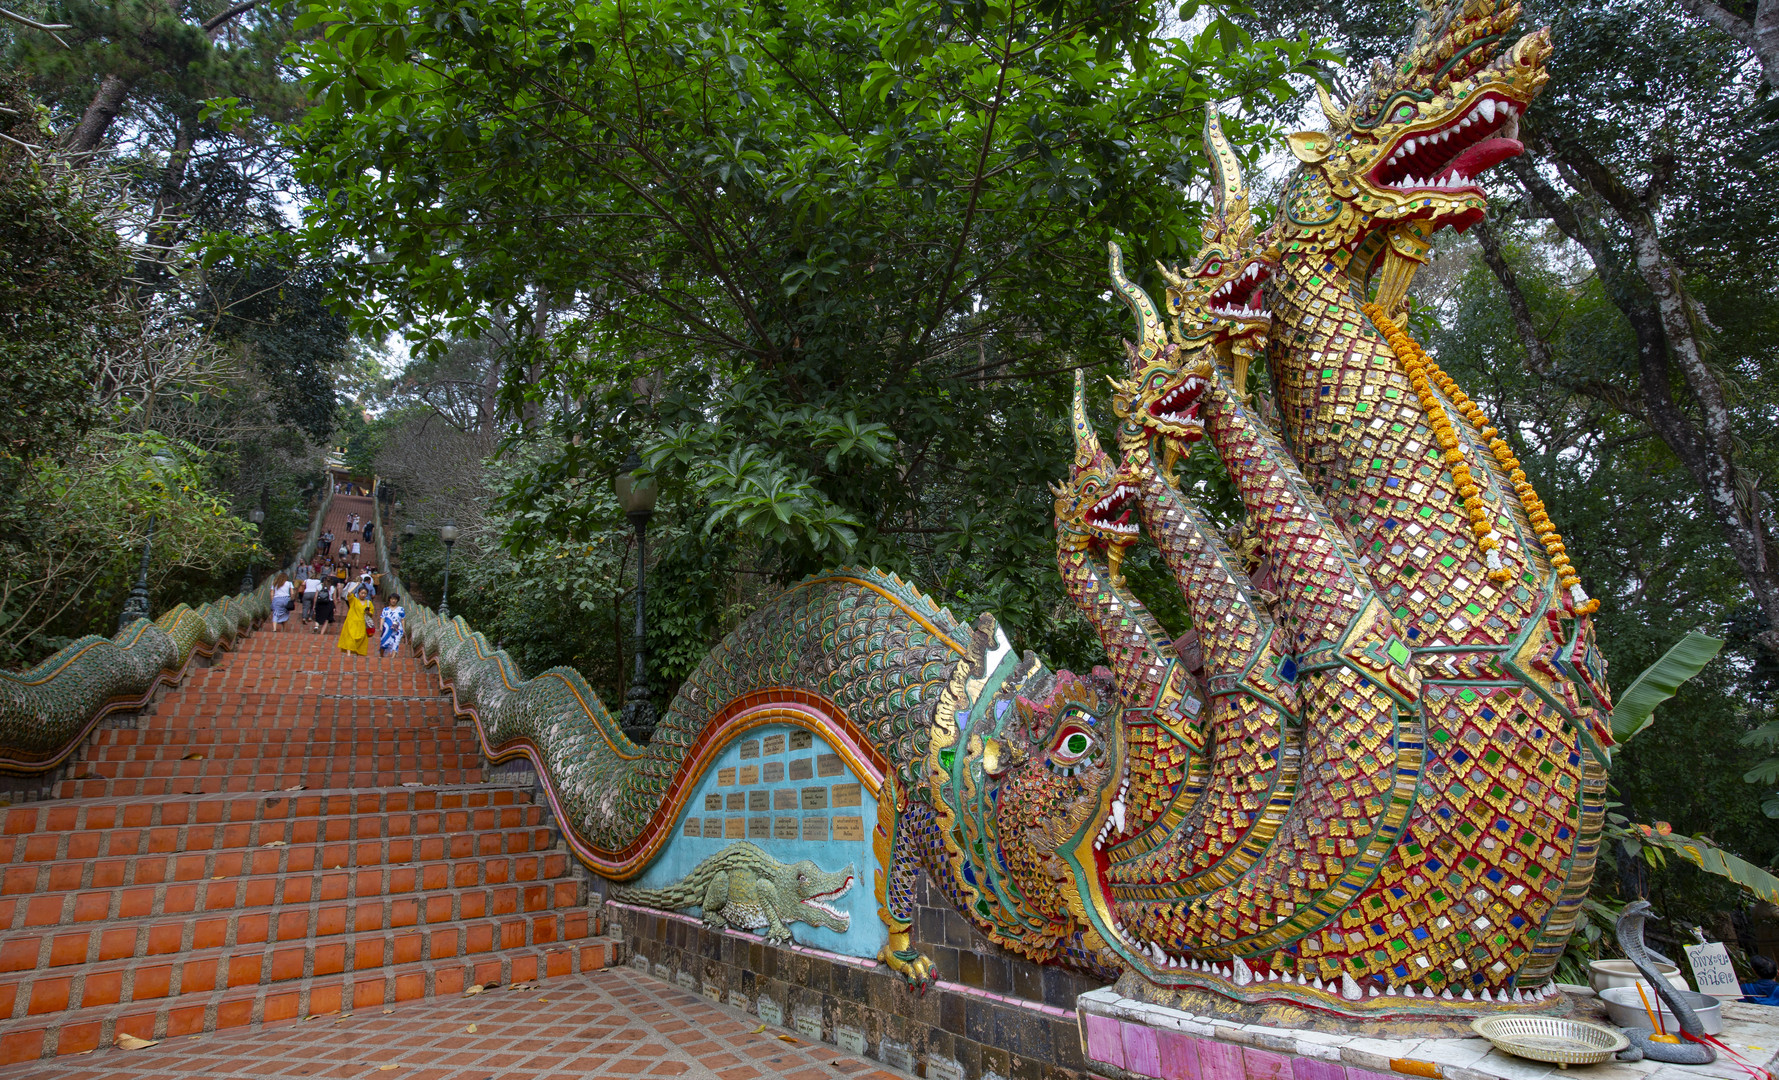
[0,0,1779,960]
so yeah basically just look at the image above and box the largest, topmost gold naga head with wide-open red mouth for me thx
[1277,0,1551,313]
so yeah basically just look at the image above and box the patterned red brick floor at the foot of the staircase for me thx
[0,968,906,1080]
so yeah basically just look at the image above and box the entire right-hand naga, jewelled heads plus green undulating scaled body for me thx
[393,0,1610,1023]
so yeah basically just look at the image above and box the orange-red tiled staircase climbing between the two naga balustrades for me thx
[0,496,616,1064]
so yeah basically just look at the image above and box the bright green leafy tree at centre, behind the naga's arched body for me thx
[297,0,1320,660]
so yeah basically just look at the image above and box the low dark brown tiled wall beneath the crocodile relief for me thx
[601,879,1101,1080]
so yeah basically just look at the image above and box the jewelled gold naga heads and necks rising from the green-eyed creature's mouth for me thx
[1017,0,1612,1023]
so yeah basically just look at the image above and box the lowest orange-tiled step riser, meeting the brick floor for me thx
[0,938,623,1064]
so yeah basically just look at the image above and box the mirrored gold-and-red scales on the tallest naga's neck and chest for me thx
[1252,258,1603,989]
